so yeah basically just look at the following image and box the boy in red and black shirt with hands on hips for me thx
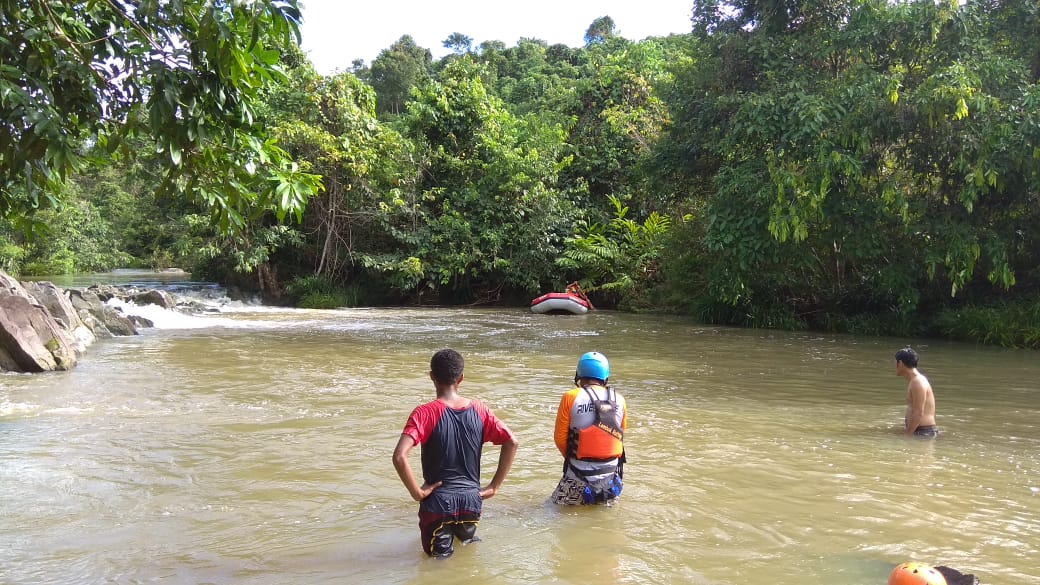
[393,350,517,558]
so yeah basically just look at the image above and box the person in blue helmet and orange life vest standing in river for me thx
[552,352,628,505]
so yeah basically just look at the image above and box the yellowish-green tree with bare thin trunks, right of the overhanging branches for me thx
[260,54,414,281]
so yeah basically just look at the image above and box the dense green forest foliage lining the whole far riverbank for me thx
[0,0,1040,348]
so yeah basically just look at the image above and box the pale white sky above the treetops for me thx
[300,0,694,75]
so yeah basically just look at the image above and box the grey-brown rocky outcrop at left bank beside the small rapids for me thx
[0,272,177,372]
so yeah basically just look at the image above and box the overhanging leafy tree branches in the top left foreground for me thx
[0,0,317,231]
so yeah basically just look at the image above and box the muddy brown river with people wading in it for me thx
[0,281,1040,585]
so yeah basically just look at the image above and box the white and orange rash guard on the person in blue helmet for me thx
[553,384,628,465]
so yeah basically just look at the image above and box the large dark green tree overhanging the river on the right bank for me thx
[657,0,1040,333]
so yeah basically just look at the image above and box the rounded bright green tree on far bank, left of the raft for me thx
[394,56,575,301]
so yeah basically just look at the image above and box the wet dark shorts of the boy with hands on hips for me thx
[419,489,484,558]
